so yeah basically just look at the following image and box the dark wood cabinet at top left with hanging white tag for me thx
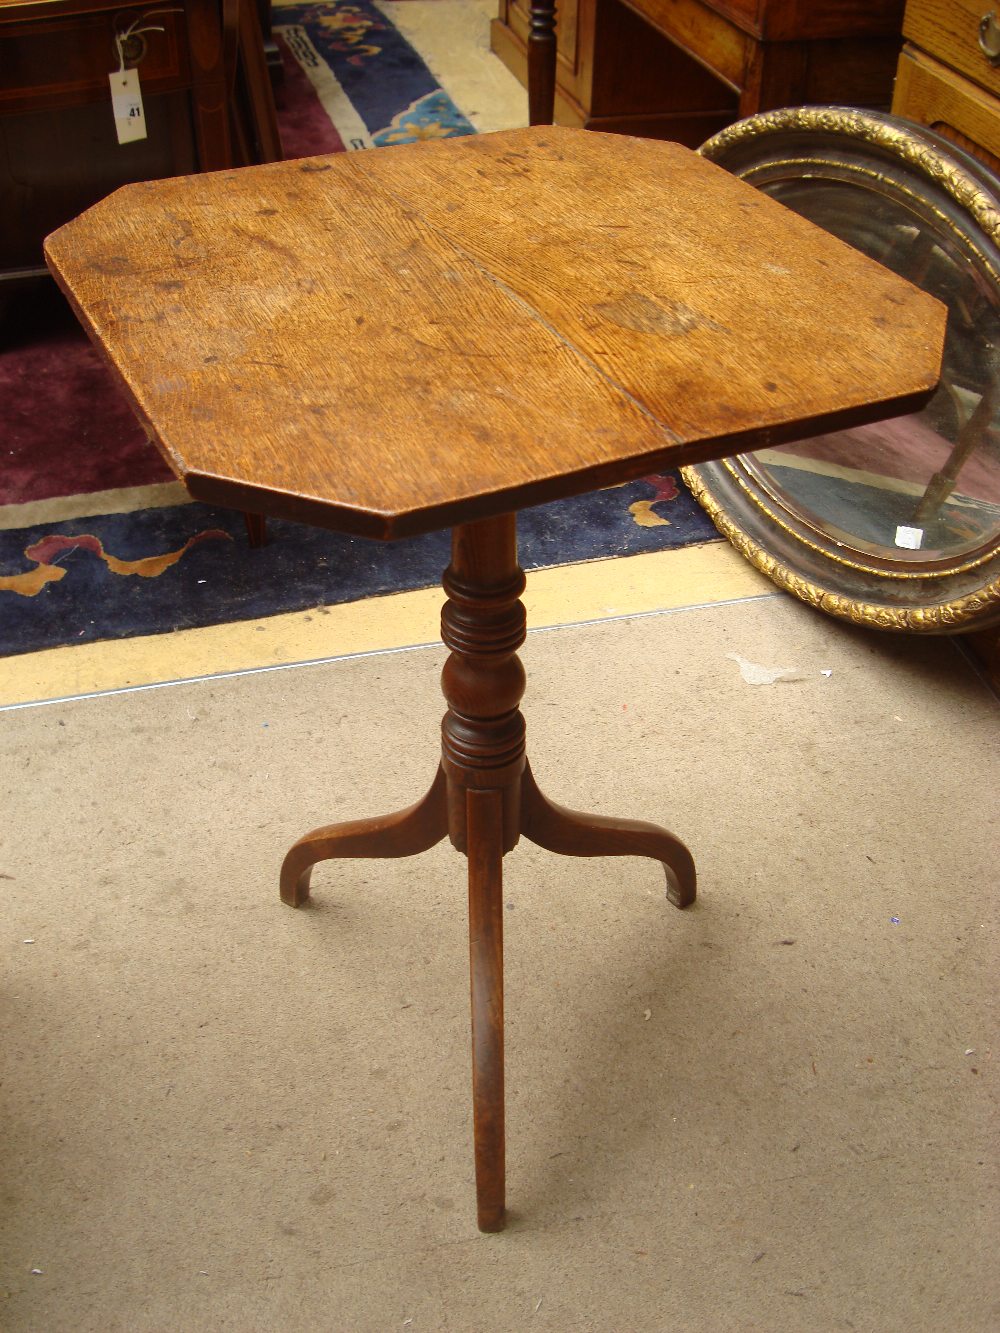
[0,0,281,280]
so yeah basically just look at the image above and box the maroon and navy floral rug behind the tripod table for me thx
[0,0,717,656]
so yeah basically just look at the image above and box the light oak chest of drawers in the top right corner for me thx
[892,0,1000,171]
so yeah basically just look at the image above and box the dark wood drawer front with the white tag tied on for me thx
[0,5,187,112]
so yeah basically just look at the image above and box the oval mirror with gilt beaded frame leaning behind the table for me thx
[684,107,1000,633]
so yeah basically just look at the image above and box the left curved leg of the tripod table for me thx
[281,768,448,908]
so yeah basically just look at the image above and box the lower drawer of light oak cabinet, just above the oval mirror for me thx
[892,48,1000,169]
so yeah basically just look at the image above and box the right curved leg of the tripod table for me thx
[521,764,697,908]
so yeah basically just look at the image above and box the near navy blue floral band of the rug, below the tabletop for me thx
[0,475,719,656]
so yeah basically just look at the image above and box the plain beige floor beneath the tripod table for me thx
[0,596,1000,1333]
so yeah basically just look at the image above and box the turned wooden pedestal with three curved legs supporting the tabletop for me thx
[281,515,696,1232]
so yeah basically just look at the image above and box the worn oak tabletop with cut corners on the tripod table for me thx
[45,127,945,537]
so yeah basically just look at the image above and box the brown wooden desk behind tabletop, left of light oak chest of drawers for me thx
[492,0,903,147]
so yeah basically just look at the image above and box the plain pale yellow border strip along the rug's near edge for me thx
[0,543,775,706]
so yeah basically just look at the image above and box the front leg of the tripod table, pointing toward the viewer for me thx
[465,789,505,1232]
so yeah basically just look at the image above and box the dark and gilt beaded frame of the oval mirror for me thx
[681,107,1000,635]
